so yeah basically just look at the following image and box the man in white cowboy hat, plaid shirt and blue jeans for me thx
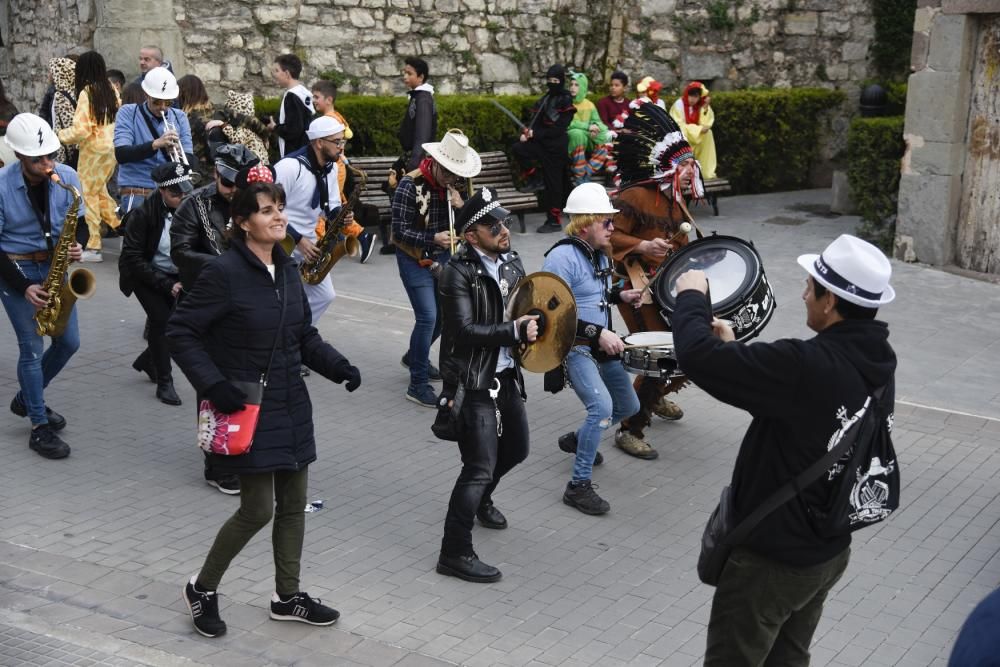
[392,129,482,408]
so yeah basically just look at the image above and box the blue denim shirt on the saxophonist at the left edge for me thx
[0,162,84,255]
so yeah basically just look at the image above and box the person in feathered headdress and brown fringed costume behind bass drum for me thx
[611,100,702,444]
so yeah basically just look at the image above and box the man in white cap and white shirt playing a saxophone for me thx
[274,116,354,324]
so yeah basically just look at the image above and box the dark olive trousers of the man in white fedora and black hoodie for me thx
[705,547,851,667]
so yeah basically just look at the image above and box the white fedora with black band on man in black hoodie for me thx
[799,234,896,308]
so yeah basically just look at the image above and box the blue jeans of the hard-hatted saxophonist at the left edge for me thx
[0,261,80,425]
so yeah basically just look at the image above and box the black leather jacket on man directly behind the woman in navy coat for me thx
[170,183,229,291]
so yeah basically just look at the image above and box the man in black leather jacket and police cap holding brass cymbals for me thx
[437,187,538,583]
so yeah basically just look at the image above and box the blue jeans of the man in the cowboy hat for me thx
[396,249,449,387]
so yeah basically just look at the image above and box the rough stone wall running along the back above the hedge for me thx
[0,0,873,111]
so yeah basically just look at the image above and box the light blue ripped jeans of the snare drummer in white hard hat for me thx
[566,345,639,482]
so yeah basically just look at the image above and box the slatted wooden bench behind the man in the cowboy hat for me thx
[348,151,538,233]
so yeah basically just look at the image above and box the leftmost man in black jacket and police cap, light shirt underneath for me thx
[118,162,191,405]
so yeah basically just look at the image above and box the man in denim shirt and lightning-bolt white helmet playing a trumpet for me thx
[115,67,198,216]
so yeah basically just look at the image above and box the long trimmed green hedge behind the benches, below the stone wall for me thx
[256,88,845,193]
